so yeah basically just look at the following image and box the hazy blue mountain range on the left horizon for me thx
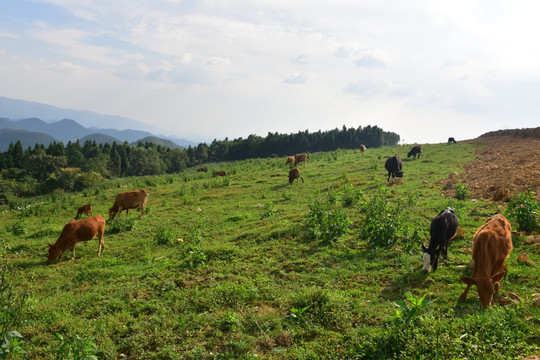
[0,96,198,151]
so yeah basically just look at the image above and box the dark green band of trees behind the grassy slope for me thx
[0,126,400,201]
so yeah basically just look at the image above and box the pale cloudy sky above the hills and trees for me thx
[0,0,540,143]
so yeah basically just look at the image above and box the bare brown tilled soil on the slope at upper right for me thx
[446,128,540,201]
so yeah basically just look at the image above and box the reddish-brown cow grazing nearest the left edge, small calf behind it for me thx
[47,215,105,265]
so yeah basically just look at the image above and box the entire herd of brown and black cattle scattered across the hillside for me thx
[47,138,512,307]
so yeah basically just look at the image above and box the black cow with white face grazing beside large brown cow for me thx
[422,207,458,272]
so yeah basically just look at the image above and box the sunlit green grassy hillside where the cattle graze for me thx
[0,144,540,359]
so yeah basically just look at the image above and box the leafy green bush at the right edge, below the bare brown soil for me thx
[506,189,540,232]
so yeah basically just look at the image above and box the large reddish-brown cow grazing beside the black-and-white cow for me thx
[458,214,512,307]
